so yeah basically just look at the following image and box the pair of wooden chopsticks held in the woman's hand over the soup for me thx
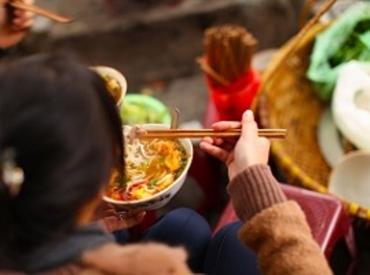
[136,129,287,139]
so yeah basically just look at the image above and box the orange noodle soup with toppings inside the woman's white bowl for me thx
[106,127,192,209]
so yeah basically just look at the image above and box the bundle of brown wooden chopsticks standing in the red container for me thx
[198,25,257,86]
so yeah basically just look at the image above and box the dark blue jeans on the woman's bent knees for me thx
[115,208,260,275]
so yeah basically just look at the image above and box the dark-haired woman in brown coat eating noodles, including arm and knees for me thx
[0,52,330,275]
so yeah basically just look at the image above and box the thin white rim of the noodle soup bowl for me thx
[103,123,194,206]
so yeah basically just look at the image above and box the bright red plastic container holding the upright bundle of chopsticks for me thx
[206,70,261,120]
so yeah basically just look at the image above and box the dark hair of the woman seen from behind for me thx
[0,55,123,269]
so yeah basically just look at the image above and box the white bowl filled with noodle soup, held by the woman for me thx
[103,124,193,210]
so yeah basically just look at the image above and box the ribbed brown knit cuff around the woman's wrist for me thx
[227,164,287,221]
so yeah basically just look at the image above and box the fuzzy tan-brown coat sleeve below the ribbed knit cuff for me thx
[240,201,332,275]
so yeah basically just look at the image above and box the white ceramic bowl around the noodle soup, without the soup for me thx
[103,124,193,211]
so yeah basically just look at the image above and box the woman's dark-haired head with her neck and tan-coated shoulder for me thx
[0,56,194,274]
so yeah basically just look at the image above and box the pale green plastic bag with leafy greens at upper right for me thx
[307,3,370,101]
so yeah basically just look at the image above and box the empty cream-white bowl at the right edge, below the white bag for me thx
[329,151,370,208]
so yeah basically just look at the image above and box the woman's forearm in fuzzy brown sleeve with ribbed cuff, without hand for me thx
[228,165,332,275]
